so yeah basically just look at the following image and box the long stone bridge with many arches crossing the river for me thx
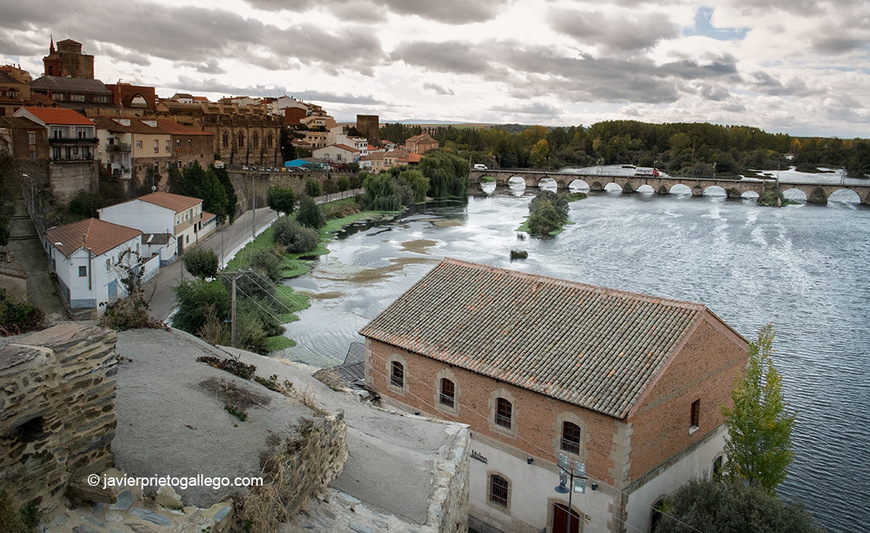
[469,170,870,205]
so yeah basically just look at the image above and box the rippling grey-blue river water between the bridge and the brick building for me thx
[285,184,870,531]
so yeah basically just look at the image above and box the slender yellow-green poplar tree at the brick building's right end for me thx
[722,324,795,492]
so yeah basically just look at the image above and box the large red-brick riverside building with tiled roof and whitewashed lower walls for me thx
[360,259,747,533]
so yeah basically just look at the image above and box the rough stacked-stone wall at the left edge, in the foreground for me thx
[0,323,118,512]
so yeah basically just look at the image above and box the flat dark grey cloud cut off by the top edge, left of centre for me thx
[242,0,513,24]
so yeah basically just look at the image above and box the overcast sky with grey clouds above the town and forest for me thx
[0,0,870,138]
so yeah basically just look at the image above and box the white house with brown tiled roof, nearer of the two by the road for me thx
[46,218,142,309]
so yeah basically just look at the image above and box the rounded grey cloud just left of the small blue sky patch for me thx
[548,9,679,52]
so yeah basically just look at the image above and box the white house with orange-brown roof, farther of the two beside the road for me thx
[99,192,216,256]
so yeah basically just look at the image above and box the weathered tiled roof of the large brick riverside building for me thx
[360,258,719,419]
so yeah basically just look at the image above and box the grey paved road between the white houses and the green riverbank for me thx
[144,207,277,321]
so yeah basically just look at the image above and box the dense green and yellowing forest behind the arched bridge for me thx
[380,120,870,177]
